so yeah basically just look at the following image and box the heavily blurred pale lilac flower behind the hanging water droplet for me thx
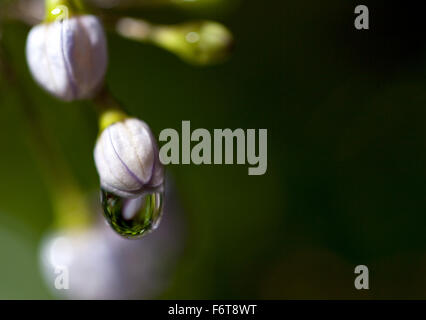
[40,180,185,299]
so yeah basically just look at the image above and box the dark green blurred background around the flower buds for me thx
[0,0,426,299]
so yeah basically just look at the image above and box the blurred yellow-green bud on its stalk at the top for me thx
[117,18,233,65]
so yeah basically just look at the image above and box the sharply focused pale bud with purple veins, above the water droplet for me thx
[94,118,163,198]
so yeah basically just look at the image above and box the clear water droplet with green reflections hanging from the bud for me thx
[101,190,163,238]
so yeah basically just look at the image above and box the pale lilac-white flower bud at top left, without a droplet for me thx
[26,15,108,101]
